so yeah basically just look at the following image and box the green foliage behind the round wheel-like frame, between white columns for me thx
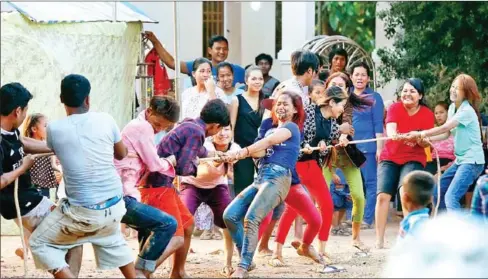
[316,1,376,53]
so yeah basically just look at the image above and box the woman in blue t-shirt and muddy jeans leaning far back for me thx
[224,92,304,278]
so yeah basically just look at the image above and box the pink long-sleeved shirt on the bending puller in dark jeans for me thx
[114,110,175,201]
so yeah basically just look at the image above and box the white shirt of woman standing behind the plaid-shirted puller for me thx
[181,86,227,120]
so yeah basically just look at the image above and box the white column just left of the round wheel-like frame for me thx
[278,1,315,80]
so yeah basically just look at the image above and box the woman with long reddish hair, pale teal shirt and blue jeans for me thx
[409,74,485,211]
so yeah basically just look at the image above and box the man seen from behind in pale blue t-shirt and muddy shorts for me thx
[30,75,136,278]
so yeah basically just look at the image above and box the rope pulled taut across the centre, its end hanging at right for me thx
[198,134,441,218]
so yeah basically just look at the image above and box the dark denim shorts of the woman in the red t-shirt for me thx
[376,161,424,198]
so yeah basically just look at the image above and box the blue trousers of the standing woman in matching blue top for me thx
[361,153,378,225]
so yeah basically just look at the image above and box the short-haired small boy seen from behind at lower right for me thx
[399,171,436,239]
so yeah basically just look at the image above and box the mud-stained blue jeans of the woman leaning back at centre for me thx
[224,164,291,269]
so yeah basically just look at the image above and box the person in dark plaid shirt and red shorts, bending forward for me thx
[139,99,230,278]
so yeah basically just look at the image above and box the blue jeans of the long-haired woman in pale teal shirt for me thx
[434,163,484,210]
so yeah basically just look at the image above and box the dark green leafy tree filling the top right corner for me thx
[378,2,488,109]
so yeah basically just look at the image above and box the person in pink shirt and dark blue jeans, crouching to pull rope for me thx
[114,96,183,278]
